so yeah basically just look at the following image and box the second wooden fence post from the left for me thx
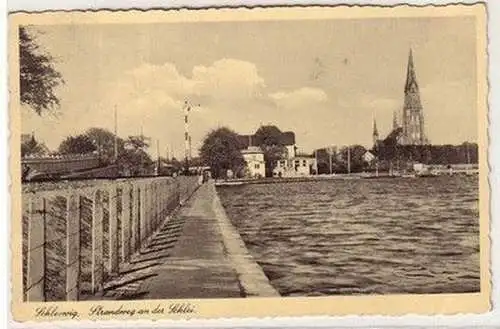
[66,194,81,300]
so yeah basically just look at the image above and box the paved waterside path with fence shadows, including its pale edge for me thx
[95,182,278,300]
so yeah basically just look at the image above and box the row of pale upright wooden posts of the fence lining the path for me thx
[24,178,200,301]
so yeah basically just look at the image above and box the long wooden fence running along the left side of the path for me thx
[22,176,199,301]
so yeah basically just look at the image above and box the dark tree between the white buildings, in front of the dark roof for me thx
[255,126,286,177]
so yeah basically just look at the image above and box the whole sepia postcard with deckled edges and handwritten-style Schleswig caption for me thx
[9,4,491,321]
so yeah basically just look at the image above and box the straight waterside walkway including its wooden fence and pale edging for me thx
[22,176,278,301]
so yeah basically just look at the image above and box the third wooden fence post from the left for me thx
[92,190,104,293]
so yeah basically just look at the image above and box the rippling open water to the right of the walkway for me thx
[219,176,480,296]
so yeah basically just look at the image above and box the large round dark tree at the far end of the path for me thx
[200,127,245,178]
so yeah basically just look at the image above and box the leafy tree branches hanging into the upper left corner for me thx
[19,26,64,114]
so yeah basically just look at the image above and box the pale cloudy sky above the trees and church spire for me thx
[22,17,477,157]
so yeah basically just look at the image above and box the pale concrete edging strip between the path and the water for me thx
[207,181,280,297]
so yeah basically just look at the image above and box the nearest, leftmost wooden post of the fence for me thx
[26,197,45,302]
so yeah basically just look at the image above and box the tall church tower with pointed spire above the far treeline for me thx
[401,49,427,145]
